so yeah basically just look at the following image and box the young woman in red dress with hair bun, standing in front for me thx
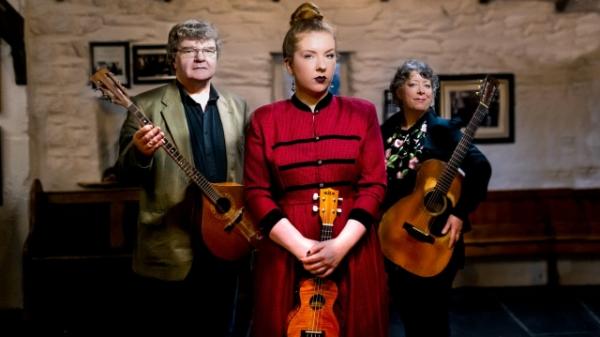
[244,3,389,337]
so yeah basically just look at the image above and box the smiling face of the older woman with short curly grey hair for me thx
[396,71,433,113]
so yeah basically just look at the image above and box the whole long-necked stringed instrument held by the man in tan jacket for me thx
[90,68,262,261]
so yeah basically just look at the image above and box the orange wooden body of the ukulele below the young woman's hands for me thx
[287,278,340,337]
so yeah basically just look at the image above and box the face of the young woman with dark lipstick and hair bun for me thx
[285,32,336,100]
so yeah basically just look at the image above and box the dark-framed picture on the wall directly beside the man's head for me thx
[133,44,175,84]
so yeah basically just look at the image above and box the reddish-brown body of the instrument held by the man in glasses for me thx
[200,182,261,261]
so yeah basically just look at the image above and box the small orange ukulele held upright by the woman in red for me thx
[287,188,341,337]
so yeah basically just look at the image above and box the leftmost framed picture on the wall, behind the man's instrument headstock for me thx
[90,41,131,88]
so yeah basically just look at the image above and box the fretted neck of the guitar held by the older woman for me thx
[435,102,488,194]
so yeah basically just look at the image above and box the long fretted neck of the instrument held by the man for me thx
[127,103,221,204]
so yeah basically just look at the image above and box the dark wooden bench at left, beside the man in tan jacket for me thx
[23,180,139,335]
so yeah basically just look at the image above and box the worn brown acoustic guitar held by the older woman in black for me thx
[378,77,498,277]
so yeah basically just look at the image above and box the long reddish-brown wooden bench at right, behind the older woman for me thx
[465,189,600,284]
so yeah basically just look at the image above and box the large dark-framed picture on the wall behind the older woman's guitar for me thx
[436,74,515,143]
